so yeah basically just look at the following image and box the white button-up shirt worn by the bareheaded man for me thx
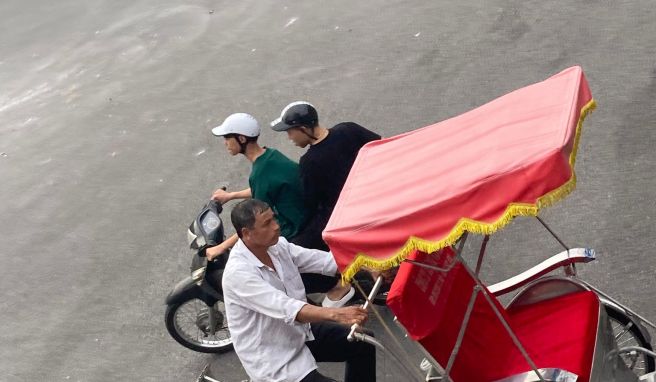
[223,237,337,382]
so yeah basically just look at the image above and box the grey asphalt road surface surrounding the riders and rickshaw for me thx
[0,0,656,381]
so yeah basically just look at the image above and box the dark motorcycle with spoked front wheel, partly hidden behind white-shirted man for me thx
[164,200,232,353]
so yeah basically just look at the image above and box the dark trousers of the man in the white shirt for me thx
[301,322,376,382]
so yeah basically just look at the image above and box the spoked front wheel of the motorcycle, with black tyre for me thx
[165,298,232,353]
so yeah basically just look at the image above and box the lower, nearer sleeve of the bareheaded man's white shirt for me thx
[224,270,307,325]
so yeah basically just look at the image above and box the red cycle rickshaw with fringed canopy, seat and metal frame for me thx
[324,67,656,382]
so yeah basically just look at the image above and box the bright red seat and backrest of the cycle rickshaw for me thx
[387,248,600,382]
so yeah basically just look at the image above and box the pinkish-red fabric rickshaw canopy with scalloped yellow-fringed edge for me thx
[323,67,595,280]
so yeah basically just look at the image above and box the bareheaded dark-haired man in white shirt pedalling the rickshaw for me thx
[223,199,376,382]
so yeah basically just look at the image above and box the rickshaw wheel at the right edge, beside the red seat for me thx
[606,308,654,376]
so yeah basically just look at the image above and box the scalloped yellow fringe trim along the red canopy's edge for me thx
[342,99,597,283]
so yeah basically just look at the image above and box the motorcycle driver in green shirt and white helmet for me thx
[205,113,353,306]
